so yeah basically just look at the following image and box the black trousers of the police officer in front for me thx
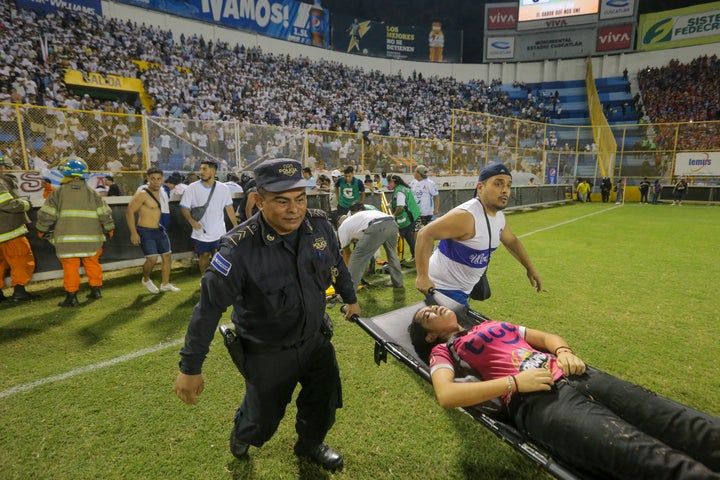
[234,332,342,447]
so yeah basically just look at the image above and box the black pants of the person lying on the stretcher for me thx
[510,370,720,480]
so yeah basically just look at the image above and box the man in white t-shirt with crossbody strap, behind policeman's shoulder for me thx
[180,160,237,274]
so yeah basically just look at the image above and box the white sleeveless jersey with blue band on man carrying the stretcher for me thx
[428,198,505,294]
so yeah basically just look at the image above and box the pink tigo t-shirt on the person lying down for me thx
[430,320,563,404]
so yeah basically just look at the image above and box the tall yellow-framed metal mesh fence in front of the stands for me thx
[0,103,720,189]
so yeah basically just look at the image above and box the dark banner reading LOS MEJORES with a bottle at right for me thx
[332,15,462,63]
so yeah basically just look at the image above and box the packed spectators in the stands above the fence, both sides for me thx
[0,3,720,169]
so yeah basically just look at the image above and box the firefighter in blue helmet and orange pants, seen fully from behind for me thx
[37,156,115,307]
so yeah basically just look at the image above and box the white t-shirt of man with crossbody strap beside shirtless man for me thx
[180,180,232,242]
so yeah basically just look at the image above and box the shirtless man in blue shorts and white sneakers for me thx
[125,167,180,293]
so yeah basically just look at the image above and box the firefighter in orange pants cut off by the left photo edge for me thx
[0,154,37,302]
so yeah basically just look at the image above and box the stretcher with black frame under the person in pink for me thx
[354,292,594,480]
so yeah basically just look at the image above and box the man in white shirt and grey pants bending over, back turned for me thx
[338,202,403,290]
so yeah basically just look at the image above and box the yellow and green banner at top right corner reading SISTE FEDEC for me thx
[637,2,720,50]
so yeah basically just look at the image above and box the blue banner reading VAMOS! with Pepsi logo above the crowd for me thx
[117,0,330,48]
